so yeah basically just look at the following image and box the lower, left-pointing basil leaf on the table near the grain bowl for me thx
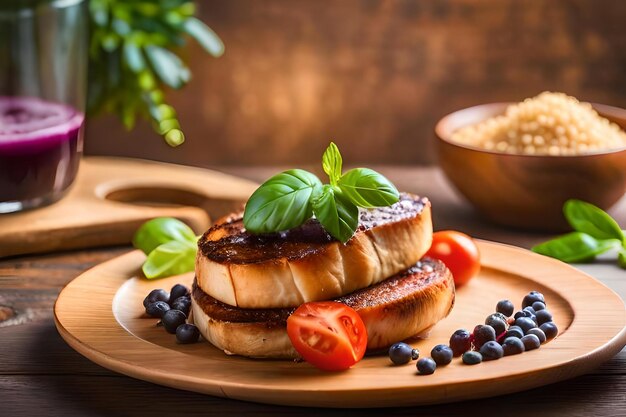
[531,232,621,263]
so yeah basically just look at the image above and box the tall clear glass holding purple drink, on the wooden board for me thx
[0,0,89,213]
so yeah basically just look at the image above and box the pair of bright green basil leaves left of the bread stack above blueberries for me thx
[133,217,198,279]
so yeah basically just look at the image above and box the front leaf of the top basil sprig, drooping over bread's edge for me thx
[313,185,359,243]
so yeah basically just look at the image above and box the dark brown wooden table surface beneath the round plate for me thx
[0,167,626,417]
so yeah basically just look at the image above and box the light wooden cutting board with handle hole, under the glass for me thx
[0,157,257,257]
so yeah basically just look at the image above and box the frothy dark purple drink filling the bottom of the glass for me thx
[0,97,84,213]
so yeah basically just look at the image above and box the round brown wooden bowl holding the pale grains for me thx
[435,103,626,231]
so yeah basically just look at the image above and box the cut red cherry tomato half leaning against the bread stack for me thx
[287,301,367,371]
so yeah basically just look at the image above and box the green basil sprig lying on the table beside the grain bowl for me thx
[531,200,626,269]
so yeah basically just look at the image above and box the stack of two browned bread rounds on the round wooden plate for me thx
[192,194,454,358]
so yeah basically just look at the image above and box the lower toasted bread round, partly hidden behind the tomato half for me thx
[191,258,455,358]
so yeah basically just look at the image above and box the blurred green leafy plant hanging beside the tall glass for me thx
[87,0,224,146]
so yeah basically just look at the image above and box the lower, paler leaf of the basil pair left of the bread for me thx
[141,240,197,279]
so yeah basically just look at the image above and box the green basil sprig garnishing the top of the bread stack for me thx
[243,142,400,243]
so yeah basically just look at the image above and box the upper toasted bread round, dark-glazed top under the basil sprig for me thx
[196,194,432,308]
